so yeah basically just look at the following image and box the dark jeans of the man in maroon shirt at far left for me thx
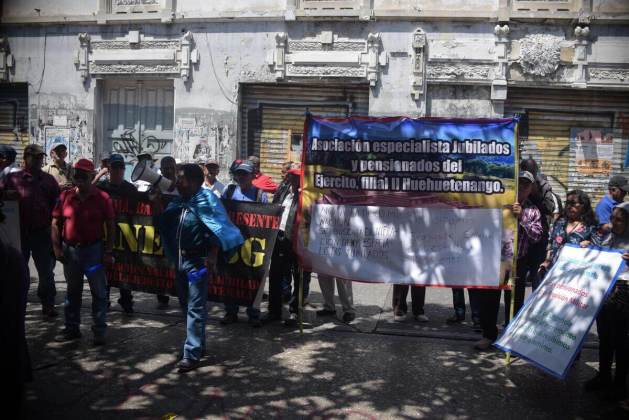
[22,229,57,305]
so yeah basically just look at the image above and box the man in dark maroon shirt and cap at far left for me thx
[0,144,59,318]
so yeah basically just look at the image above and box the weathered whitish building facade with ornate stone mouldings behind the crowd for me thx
[0,0,629,199]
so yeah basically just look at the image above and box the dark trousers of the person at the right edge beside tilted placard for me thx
[596,304,629,387]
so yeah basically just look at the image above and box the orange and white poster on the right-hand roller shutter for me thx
[570,128,614,176]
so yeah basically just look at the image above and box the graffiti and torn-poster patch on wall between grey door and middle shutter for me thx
[173,110,236,168]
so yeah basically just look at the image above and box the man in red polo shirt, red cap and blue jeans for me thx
[52,159,114,346]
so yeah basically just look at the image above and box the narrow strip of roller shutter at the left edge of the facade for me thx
[0,83,29,162]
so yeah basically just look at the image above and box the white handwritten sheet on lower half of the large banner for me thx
[308,204,502,286]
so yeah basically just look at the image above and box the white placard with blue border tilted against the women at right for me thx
[495,245,626,379]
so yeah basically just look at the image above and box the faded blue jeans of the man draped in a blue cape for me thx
[175,271,209,360]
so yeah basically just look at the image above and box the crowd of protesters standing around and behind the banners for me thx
[0,144,629,399]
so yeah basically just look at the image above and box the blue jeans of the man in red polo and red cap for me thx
[63,241,107,335]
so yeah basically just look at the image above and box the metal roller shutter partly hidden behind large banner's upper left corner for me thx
[241,84,369,182]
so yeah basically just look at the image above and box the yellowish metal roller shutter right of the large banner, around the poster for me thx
[505,88,629,203]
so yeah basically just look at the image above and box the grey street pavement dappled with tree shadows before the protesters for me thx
[26,269,629,420]
